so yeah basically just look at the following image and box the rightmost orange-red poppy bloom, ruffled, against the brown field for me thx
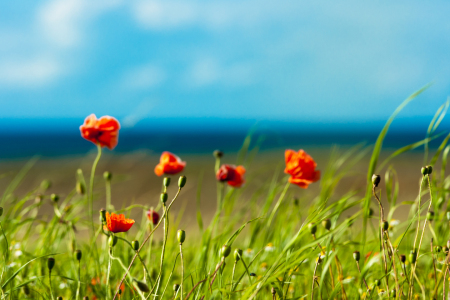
[284,150,320,189]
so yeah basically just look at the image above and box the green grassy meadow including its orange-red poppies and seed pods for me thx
[0,89,450,300]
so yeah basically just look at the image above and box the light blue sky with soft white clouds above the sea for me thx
[0,0,450,127]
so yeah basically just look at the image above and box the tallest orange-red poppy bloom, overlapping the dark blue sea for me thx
[80,114,120,149]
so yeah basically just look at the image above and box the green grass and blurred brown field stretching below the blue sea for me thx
[0,88,450,300]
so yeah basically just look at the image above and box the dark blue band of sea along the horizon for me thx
[0,117,444,160]
